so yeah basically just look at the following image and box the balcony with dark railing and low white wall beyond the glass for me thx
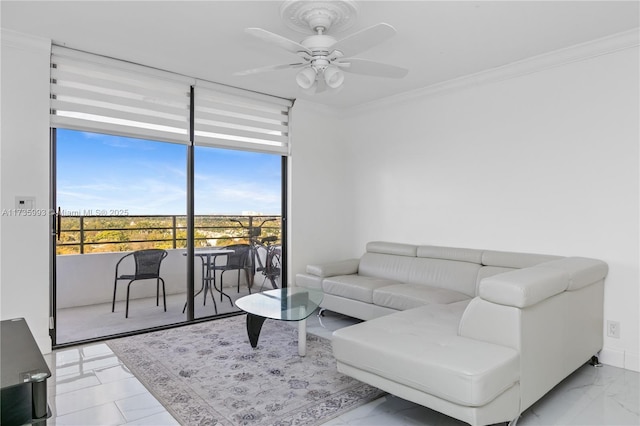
[56,216,281,345]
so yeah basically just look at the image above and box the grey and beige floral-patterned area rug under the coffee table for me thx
[107,315,384,426]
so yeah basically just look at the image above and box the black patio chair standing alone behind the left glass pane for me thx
[111,249,167,318]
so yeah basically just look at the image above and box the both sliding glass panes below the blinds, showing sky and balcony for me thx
[52,129,284,346]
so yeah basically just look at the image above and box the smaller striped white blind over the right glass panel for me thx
[194,80,293,155]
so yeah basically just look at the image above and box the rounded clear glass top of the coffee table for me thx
[236,287,324,321]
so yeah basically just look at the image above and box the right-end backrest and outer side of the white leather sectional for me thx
[458,258,608,410]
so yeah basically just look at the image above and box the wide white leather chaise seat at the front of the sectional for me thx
[332,301,520,407]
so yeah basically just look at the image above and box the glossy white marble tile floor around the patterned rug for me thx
[45,312,640,426]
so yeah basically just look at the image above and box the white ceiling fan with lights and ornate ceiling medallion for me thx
[235,0,409,93]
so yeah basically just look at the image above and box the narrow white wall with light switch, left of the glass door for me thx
[0,30,51,352]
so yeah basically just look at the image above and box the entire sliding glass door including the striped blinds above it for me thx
[50,46,293,346]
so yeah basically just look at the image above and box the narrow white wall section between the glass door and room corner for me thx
[289,100,354,283]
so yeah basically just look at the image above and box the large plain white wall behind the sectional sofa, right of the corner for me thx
[346,44,640,370]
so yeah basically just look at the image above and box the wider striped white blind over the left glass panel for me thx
[51,46,195,144]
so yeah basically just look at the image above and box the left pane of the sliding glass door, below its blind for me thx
[54,129,186,345]
